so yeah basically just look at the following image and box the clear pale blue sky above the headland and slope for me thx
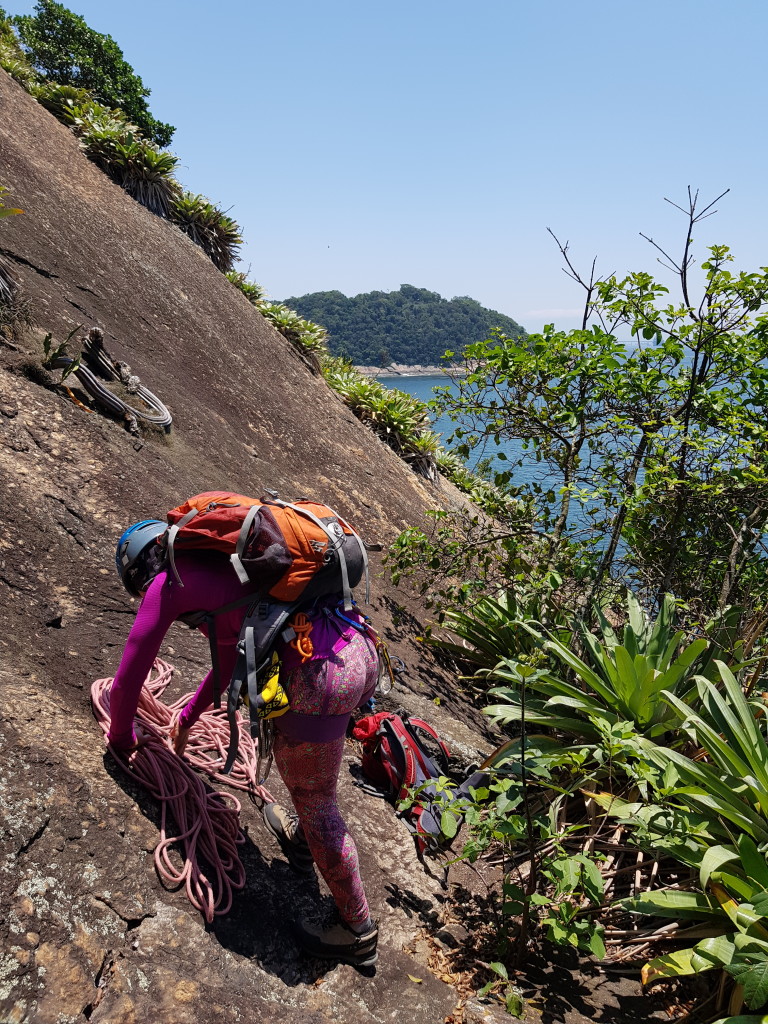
[7,0,768,331]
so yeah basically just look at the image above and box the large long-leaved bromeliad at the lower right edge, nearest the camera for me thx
[596,662,768,1024]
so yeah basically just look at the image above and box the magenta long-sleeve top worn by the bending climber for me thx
[108,552,255,750]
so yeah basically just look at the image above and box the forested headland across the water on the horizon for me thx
[285,285,525,367]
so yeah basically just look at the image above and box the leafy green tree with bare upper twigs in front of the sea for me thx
[439,194,768,613]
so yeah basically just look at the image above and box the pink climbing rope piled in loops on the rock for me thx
[91,658,272,924]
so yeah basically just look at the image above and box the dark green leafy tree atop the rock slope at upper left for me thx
[12,0,175,146]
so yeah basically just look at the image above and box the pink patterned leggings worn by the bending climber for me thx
[274,635,377,925]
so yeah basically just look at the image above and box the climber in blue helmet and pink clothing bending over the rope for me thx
[108,519,378,967]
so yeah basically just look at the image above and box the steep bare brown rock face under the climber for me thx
[0,72,495,1024]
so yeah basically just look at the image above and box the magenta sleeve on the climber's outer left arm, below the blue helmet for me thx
[106,572,177,751]
